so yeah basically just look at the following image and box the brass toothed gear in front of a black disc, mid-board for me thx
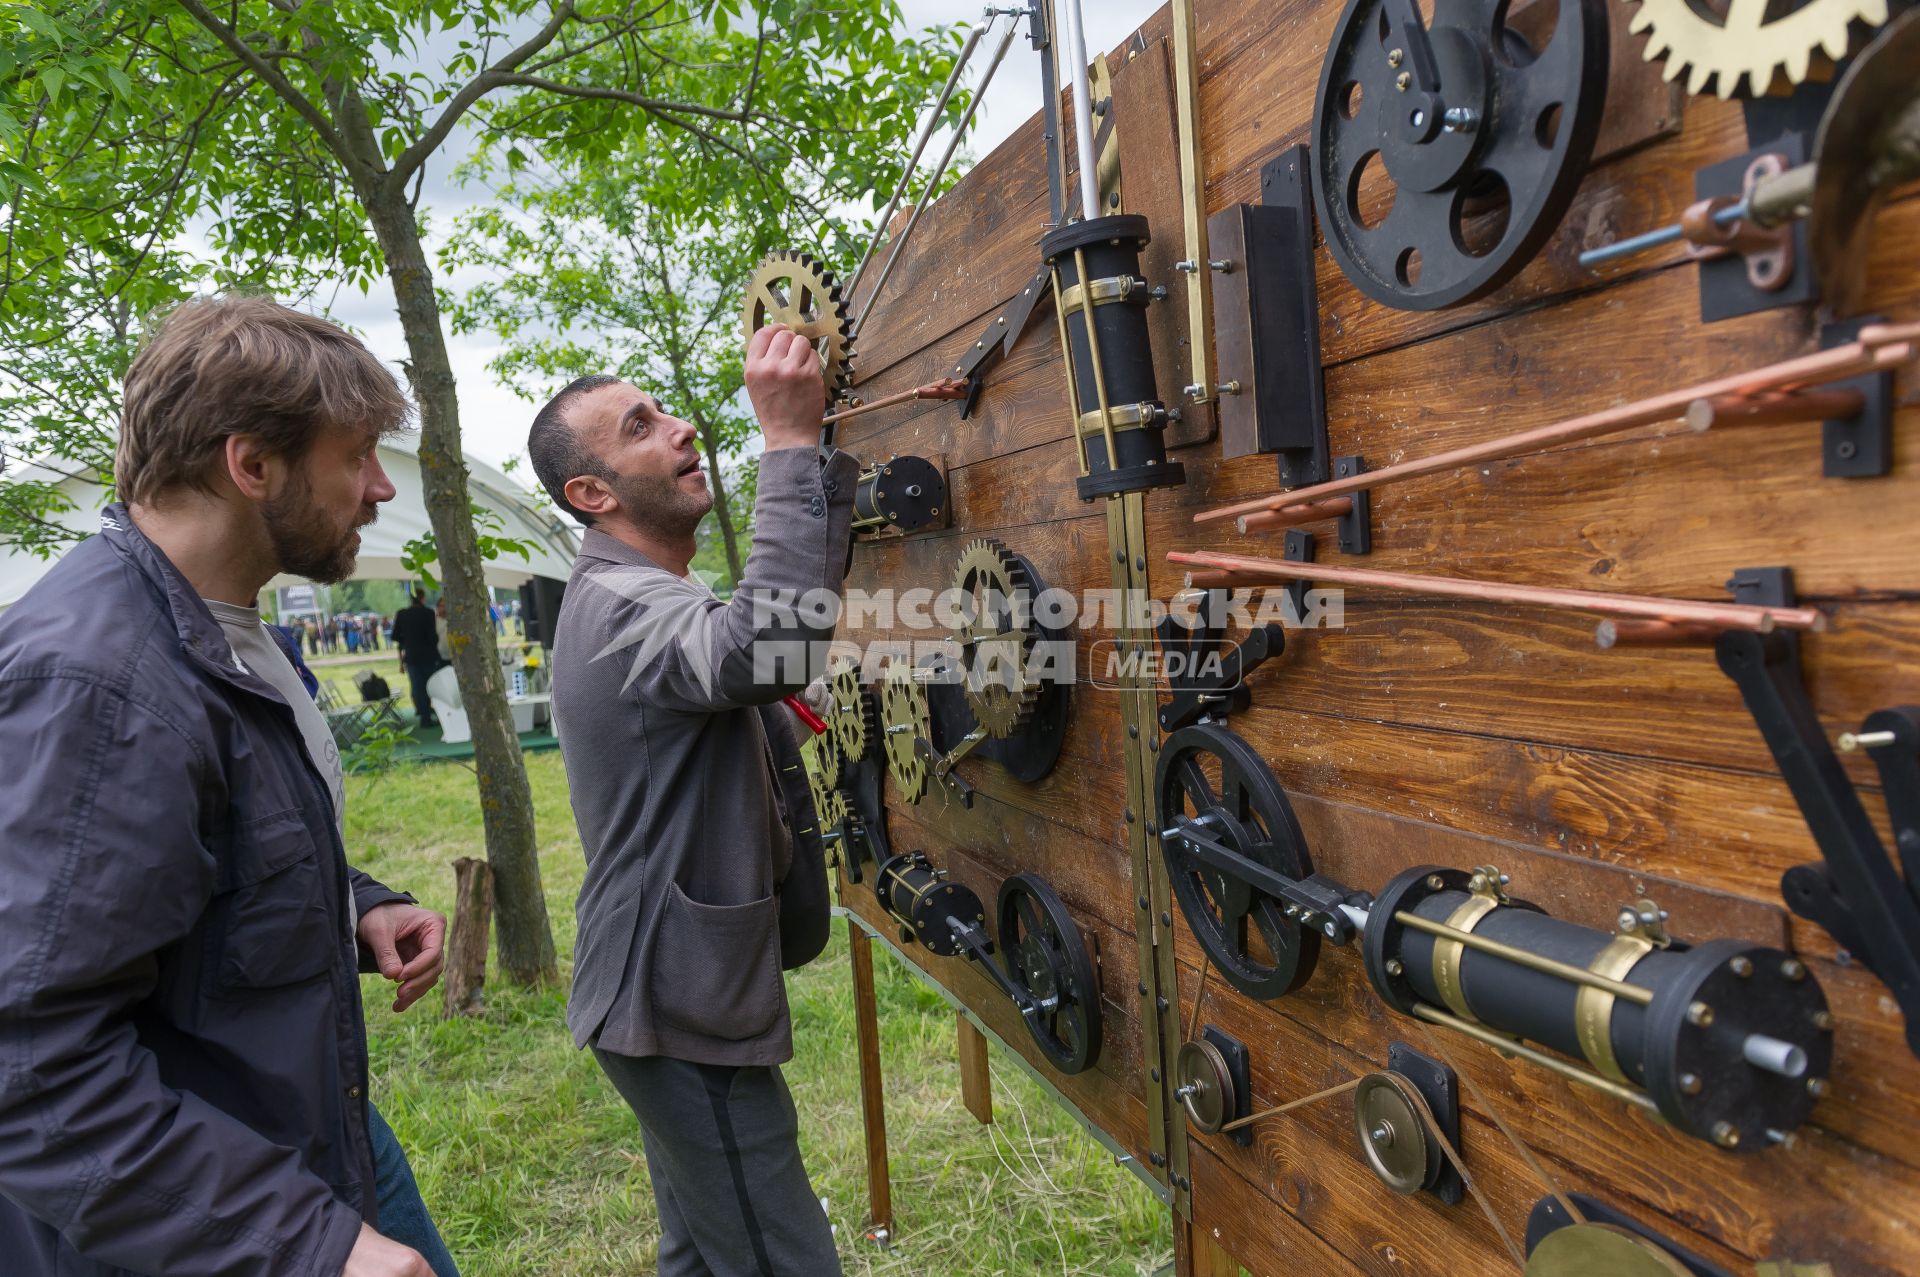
[954,538,1041,739]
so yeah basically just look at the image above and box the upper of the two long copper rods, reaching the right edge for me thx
[1194,334,1920,522]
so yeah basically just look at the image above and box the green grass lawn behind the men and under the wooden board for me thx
[348,755,1171,1277]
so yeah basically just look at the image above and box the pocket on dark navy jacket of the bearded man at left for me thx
[207,812,340,995]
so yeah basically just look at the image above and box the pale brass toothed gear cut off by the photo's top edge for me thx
[1628,0,1887,98]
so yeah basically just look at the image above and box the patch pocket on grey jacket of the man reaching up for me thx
[647,883,783,1043]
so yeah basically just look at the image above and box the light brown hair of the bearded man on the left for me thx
[113,294,413,503]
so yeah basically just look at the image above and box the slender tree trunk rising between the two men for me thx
[355,181,559,985]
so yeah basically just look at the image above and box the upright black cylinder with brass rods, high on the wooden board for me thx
[1041,213,1187,501]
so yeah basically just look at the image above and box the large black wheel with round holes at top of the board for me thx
[1313,0,1607,311]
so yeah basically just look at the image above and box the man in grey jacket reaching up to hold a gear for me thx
[528,325,856,1277]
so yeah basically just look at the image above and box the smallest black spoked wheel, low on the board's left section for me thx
[1000,874,1100,1073]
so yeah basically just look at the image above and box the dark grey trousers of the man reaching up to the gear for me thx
[593,1047,841,1277]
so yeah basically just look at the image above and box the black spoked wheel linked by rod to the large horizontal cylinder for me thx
[1154,722,1319,1000]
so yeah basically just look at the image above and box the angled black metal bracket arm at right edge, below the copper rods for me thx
[1715,568,1920,1056]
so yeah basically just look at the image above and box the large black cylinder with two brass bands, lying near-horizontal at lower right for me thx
[1365,866,1832,1148]
